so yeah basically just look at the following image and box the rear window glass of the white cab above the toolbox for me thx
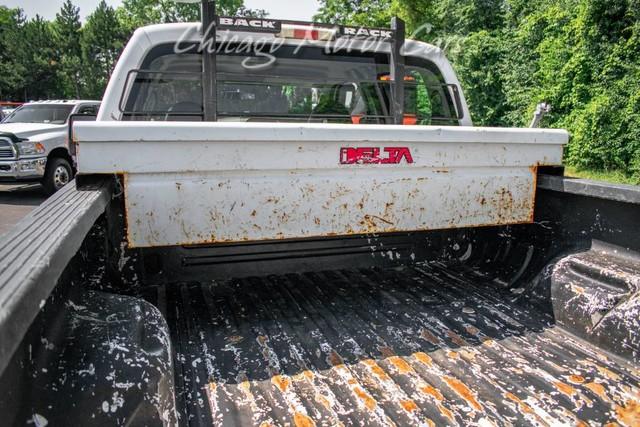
[120,44,461,125]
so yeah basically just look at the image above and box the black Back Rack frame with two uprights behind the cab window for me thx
[202,0,406,125]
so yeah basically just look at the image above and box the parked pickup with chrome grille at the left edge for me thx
[0,100,100,194]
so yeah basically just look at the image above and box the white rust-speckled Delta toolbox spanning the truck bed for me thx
[75,122,567,247]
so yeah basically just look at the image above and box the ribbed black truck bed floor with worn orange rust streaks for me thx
[149,264,640,426]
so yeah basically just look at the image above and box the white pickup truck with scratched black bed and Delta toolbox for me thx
[0,13,640,425]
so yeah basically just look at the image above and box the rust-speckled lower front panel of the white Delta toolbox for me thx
[124,166,537,247]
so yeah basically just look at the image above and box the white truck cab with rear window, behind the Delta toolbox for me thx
[99,19,472,126]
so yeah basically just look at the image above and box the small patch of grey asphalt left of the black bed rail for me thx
[0,184,46,236]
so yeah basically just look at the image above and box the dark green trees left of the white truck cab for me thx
[0,0,266,101]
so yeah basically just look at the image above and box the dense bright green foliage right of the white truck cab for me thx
[315,0,640,179]
